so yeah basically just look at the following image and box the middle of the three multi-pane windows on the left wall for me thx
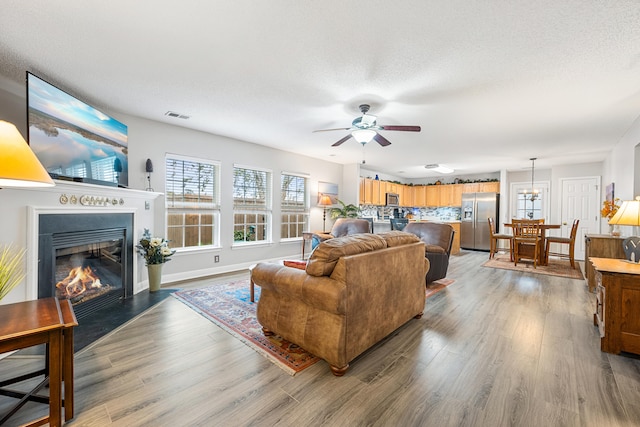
[233,166,271,244]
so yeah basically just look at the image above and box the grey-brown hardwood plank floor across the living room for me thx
[0,251,640,427]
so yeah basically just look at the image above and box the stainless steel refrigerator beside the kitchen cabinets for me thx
[460,193,500,251]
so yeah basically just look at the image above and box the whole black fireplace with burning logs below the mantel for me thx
[38,213,133,319]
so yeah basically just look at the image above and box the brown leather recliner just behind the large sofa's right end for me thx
[403,222,455,283]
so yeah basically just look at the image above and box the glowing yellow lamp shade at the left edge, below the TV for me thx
[0,120,55,187]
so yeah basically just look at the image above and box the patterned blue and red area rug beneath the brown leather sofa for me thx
[172,279,454,375]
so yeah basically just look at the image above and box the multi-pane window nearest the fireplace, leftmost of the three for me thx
[165,155,220,248]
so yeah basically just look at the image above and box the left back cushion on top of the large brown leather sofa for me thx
[307,233,387,277]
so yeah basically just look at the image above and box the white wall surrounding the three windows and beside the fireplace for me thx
[0,76,344,303]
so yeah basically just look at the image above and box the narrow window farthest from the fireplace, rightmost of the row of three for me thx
[280,173,309,239]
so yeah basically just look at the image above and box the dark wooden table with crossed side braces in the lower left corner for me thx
[0,298,78,427]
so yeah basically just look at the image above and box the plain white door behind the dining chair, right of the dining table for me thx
[552,177,600,260]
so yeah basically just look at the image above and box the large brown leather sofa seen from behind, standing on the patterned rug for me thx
[251,232,429,376]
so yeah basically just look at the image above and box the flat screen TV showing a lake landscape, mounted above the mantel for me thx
[27,72,129,187]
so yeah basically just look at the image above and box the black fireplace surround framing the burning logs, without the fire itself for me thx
[38,213,134,319]
